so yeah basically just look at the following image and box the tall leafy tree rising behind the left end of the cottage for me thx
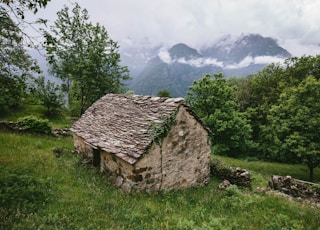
[44,3,130,114]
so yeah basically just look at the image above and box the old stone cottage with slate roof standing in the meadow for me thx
[71,94,210,192]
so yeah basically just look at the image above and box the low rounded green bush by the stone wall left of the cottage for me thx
[18,116,52,134]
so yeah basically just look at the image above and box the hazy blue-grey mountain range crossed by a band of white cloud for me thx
[128,34,291,97]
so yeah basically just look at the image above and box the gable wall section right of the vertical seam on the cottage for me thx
[161,106,211,189]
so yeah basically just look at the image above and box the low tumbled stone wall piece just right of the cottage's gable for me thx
[210,160,251,189]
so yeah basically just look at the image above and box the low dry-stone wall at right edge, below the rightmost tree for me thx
[268,175,320,202]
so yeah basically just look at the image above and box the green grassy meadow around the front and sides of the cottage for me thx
[0,132,320,230]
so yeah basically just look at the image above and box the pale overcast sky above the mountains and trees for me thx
[30,0,320,56]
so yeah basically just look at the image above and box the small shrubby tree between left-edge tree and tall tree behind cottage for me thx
[32,76,64,114]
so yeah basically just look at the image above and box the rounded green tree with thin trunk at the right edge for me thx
[265,76,320,180]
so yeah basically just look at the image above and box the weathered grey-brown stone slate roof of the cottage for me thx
[71,94,184,164]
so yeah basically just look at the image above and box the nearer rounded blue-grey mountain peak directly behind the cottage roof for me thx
[131,43,222,97]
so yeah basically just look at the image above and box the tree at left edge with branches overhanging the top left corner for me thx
[0,0,48,111]
